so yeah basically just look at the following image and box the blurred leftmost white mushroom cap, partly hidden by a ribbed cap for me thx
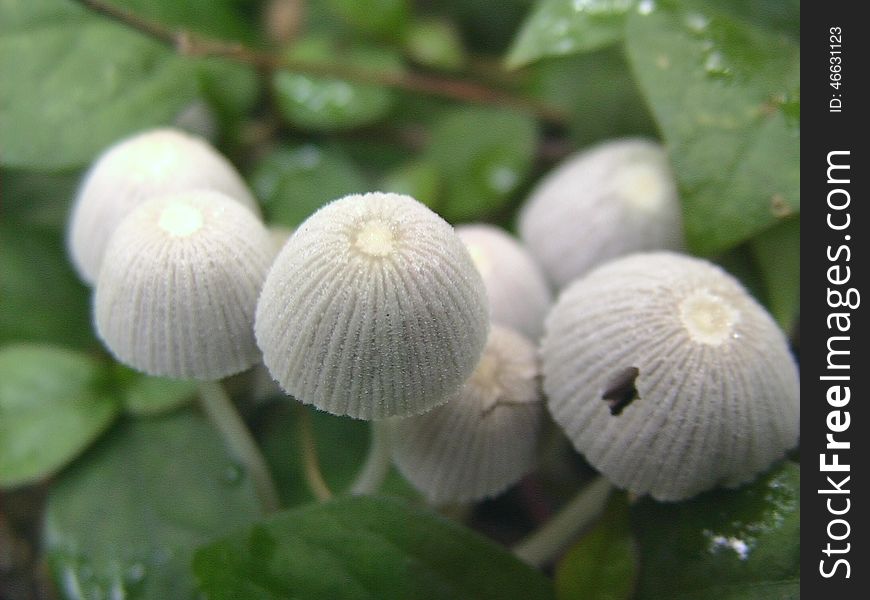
[67,128,260,284]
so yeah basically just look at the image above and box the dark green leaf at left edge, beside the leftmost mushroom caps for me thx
[0,222,97,348]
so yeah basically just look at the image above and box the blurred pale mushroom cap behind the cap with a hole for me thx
[518,138,683,287]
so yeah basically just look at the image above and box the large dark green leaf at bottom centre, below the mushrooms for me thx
[193,497,552,600]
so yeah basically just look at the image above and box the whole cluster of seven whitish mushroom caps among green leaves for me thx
[69,129,800,504]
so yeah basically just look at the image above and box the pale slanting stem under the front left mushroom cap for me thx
[199,381,280,513]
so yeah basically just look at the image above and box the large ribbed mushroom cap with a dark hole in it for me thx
[541,252,800,500]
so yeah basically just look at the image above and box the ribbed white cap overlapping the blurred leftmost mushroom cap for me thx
[94,190,275,379]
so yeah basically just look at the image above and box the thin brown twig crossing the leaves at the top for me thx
[74,0,566,124]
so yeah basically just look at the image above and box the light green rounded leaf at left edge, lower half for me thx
[0,344,118,487]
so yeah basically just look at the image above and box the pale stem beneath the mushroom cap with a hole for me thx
[513,477,613,567]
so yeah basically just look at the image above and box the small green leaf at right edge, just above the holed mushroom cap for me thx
[750,217,801,334]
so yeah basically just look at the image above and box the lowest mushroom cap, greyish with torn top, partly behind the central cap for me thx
[391,324,544,504]
